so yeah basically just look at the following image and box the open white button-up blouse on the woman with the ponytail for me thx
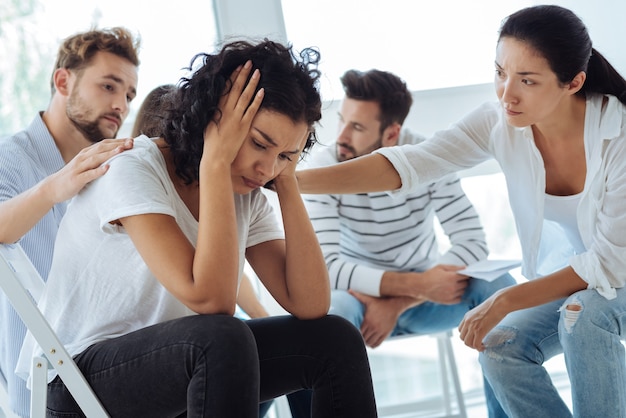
[375,95,626,299]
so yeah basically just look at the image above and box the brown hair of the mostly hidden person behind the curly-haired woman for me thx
[131,84,176,138]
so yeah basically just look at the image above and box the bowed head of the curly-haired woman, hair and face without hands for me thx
[164,39,322,189]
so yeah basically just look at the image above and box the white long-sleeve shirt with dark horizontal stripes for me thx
[304,130,488,296]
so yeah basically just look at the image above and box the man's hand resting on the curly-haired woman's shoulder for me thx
[42,138,133,206]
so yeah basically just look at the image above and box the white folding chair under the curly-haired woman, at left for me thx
[0,244,109,418]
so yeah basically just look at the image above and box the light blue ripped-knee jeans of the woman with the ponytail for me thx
[479,289,626,418]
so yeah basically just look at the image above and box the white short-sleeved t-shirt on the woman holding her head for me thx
[16,136,284,379]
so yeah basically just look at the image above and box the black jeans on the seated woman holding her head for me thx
[48,315,376,418]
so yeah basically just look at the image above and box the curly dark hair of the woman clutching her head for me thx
[164,39,322,184]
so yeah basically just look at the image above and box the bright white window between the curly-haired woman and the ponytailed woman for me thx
[282,0,534,100]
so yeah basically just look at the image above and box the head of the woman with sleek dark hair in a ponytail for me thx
[496,5,626,125]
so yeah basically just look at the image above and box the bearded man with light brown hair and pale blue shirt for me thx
[0,28,139,417]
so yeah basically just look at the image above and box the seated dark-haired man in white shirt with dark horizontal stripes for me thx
[305,70,515,347]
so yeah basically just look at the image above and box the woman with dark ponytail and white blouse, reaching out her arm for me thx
[297,6,626,418]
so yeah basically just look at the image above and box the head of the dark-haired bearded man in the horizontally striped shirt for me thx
[336,69,413,161]
